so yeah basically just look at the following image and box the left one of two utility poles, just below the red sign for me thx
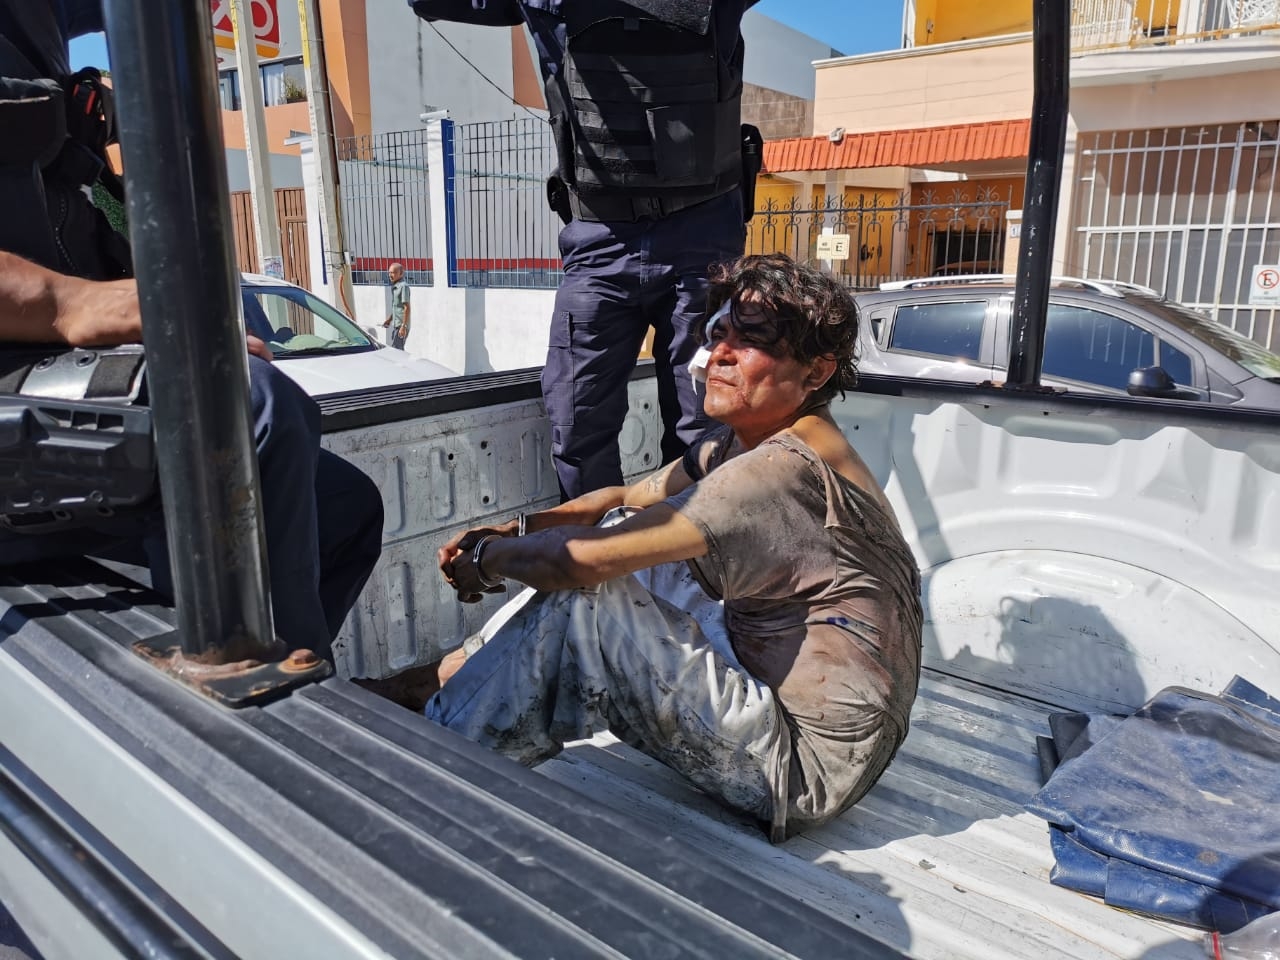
[230,0,284,279]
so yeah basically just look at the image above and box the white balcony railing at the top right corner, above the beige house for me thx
[1071,0,1280,56]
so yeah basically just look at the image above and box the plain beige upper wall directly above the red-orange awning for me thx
[813,41,1032,134]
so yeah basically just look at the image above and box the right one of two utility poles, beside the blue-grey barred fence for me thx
[298,0,355,316]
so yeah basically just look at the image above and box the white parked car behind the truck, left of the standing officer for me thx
[241,274,458,397]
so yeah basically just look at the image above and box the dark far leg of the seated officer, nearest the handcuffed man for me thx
[316,449,383,636]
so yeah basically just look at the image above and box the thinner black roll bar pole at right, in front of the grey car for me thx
[1005,0,1071,390]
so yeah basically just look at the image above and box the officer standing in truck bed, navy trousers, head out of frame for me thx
[410,0,758,498]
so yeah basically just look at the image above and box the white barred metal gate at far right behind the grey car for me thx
[1073,120,1280,349]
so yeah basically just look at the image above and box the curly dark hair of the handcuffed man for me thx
[698,253,858,401]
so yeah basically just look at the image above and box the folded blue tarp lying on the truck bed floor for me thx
[1028,678,1280,933]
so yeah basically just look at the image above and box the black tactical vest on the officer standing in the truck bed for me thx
[547,0,742,220]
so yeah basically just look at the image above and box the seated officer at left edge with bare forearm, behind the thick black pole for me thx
[0,0,383,655]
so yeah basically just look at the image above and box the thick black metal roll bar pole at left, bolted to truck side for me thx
[106,0,283,664]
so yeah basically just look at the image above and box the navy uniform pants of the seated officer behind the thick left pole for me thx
[0,357,383,658]
